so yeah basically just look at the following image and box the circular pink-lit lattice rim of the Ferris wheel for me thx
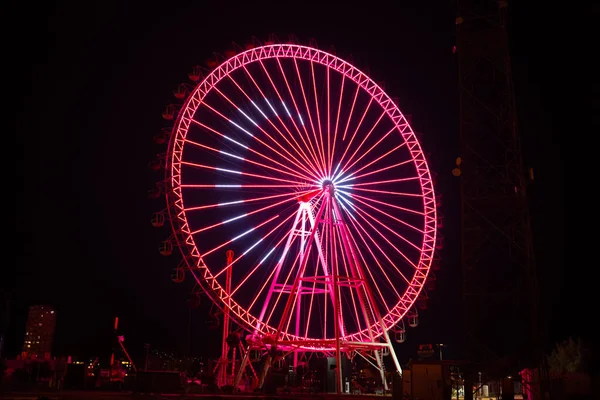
[165,44,437,350]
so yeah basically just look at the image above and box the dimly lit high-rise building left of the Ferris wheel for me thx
[23,305,56,357]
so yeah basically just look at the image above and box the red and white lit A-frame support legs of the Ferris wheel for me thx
[234,186,402,390]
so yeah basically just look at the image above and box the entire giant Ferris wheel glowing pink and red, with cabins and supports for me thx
[153,43,438,394]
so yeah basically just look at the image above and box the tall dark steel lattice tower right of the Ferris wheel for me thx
[454,0,540,374]
